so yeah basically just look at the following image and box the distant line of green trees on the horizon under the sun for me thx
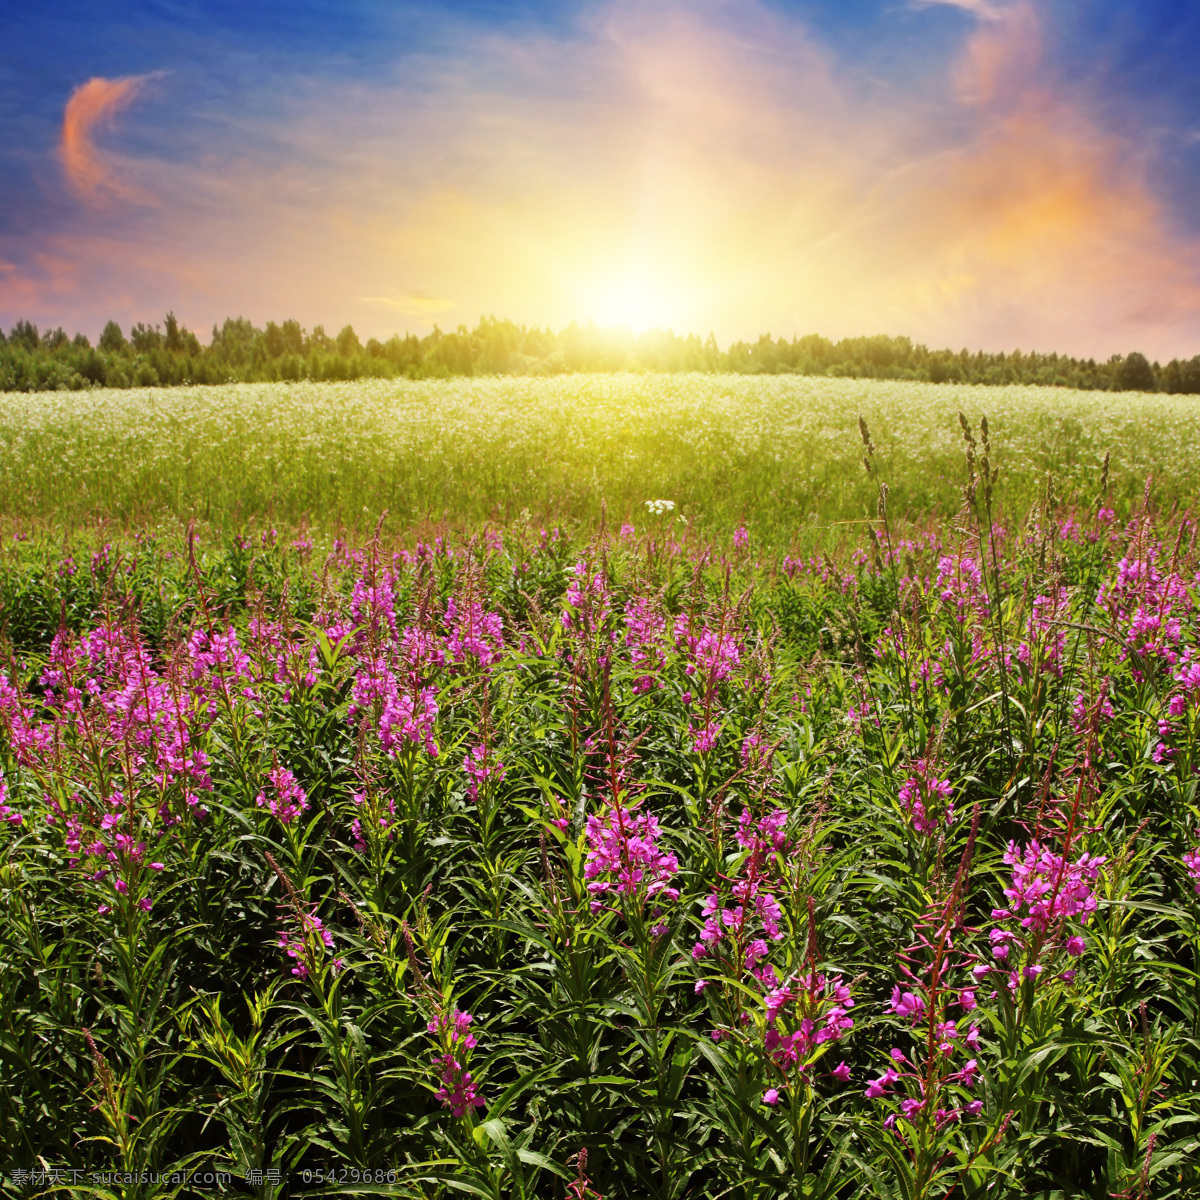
[0,313,1200,394]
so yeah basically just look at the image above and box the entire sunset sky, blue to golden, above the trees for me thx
[0,0,1200,361]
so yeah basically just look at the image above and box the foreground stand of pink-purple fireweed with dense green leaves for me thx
[0,436,1200,1200]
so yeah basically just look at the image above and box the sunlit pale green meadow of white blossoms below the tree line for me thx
[0,374,1200,545]
